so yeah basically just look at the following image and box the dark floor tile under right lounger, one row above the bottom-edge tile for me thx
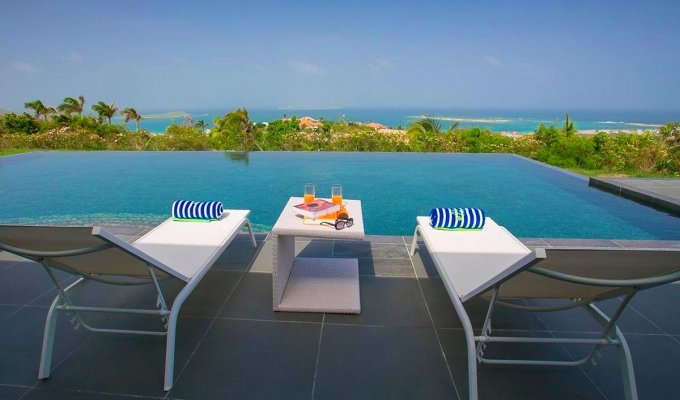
[419,279,545,330]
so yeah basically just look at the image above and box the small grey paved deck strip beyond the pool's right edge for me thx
[588,178,680,215]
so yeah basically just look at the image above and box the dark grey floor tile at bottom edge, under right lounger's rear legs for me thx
[438,329,605,400]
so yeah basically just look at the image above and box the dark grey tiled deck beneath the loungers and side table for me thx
[0,227,680,400]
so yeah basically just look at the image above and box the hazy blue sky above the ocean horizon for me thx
[0,0,680,111]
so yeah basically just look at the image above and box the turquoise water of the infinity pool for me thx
[0,152,680,240]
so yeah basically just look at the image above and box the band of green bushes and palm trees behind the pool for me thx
[0,96,680,176]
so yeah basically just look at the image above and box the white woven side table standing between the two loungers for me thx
[272,197,364,314]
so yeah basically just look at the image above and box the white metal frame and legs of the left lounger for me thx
[0,218,257,391]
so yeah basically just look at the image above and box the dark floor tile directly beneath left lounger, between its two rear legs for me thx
[39,318,210,396]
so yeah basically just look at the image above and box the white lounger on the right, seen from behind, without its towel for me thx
[411,217,680,399]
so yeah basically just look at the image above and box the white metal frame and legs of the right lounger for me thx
[410,225,680,400]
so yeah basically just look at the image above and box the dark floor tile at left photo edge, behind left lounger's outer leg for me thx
[0,307,88,386]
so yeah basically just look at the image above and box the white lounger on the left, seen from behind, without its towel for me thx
[0,210,257,391]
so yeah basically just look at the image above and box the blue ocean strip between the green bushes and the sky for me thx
[113,108,680,133]
